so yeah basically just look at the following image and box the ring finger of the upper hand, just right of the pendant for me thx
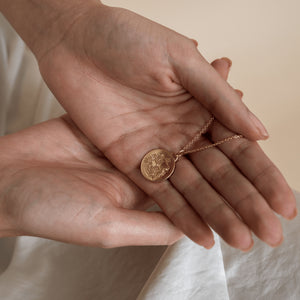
[170,158,253,251]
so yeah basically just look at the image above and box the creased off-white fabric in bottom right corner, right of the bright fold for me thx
[221,192,300,300]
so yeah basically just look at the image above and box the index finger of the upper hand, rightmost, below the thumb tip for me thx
[212,123,297,219]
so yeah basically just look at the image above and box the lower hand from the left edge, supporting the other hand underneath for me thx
[0,116,182,248]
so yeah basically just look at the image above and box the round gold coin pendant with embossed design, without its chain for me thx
[141,149,175,182]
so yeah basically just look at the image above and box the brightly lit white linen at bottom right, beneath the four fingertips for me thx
[138,209,300,300]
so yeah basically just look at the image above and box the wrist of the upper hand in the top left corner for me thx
[0,0,102,60]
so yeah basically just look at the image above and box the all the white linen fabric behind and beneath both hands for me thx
[0,15,300,300]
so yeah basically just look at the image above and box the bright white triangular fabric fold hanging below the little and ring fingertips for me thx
[137,235,229,300]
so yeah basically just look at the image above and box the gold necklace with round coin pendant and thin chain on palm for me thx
[141,117,243,182]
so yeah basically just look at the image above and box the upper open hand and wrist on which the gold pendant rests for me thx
[0,1,297,251]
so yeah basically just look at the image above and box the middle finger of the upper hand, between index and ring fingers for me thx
[191,141,282,246]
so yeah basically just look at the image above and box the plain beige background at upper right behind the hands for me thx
[104,0,300,190]
